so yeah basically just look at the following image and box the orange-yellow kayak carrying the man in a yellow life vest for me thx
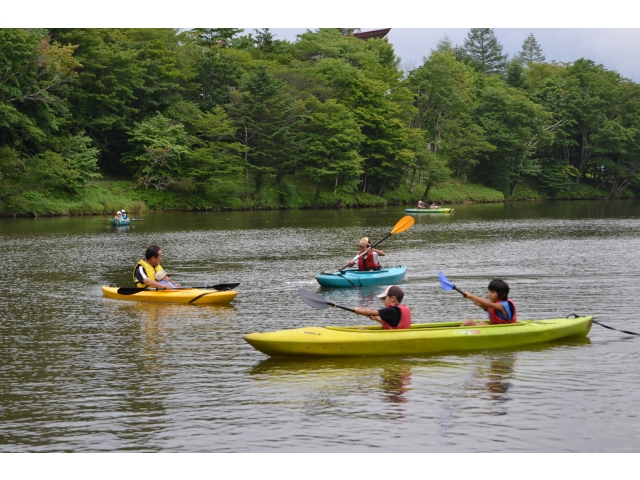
[102,286,238,305]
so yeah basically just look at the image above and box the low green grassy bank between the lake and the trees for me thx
[0,177,635,216]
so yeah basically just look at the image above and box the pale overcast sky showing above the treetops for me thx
[268,27,640,83]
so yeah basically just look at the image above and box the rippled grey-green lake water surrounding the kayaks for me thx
[0,201,640,452]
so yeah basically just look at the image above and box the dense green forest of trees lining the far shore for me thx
[0,28,640,212]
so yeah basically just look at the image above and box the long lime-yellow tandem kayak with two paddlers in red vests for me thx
[244,317,593,357]
